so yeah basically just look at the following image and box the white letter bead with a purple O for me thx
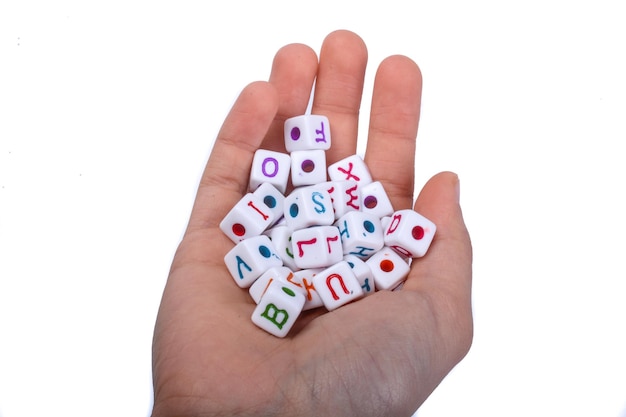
[250,149,291,193]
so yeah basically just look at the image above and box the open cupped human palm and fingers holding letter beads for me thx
[153,31,472,417]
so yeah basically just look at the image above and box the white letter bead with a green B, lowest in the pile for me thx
[252,281,304,337]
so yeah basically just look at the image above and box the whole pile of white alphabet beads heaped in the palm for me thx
[220,115,436,337]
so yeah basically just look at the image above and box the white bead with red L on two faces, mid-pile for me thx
[291,226,343,269]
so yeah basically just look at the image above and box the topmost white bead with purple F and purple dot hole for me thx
[284,114,330,152]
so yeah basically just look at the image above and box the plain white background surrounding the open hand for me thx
[0,0,626,417]
